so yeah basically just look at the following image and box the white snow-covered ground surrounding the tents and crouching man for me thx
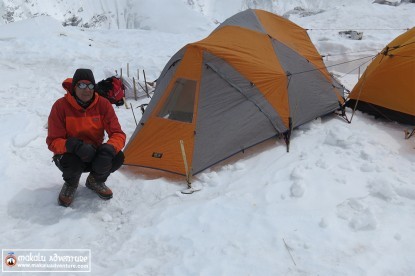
[0,0,415,276]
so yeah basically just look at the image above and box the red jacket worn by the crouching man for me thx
[46,89,125,154]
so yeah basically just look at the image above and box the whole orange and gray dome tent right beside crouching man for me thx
[124,9,343,175]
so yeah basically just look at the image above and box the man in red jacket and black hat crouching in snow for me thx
[46,69,125,207]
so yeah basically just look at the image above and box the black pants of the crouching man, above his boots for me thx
[53,148,124,185]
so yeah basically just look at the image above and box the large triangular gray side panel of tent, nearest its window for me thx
[193,55,282,174]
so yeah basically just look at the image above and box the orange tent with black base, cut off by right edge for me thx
[346,28,415,125]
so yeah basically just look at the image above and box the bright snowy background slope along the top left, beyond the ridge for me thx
[0,0,212,33]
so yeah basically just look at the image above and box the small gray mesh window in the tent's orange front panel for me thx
[158,79,196,123]
